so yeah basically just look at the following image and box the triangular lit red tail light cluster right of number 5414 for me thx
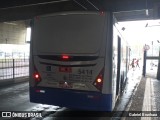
[93,69,104,91]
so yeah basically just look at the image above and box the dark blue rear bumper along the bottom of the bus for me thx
[30,87,112,111]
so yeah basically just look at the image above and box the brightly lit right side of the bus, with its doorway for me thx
[112,14,128,108]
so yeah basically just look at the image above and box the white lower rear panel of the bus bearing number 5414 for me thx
[33,56,104,92]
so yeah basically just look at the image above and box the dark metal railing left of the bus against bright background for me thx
[0,59,29,80]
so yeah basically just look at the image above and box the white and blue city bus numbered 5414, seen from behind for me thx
[29,11,129,111]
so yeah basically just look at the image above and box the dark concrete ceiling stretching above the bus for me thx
[0,0,159,22]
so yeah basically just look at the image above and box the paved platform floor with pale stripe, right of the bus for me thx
[125,77,160,120]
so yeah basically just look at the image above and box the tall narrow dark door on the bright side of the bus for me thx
[116,36,121,95]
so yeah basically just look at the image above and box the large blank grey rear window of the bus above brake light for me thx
[33,14,104,54]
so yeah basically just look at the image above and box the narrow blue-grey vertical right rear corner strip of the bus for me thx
[103,13,115,110]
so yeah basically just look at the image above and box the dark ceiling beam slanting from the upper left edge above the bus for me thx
[0,1,80,22]
